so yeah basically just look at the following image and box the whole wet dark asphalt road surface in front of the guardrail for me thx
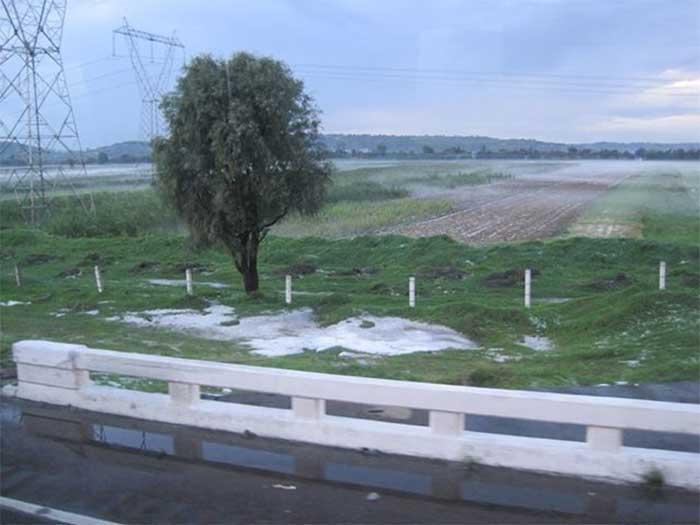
[0,398,699,523]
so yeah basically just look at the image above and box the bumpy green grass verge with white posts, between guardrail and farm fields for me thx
[0,229,700,388]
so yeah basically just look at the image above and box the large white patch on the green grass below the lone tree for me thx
[108,305,477,357]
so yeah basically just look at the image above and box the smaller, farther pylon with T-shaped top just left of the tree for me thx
[112,18,185,142]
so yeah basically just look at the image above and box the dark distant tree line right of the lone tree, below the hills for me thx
[327,144,700,160]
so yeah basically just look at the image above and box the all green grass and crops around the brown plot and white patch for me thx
[0,162,700,388]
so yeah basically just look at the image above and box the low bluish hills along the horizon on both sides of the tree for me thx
[0,133,700,166]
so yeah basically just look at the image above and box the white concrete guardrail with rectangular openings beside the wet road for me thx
[13,341,700,490]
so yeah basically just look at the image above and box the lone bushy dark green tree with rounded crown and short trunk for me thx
[154,53,330,294]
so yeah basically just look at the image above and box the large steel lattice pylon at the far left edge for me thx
[0,0,94,224]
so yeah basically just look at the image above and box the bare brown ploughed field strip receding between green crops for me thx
[390,161,692,244]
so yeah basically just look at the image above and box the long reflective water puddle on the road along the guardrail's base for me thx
[6,402,698,522]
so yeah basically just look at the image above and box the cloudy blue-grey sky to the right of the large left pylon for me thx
[54,0,700,147]
